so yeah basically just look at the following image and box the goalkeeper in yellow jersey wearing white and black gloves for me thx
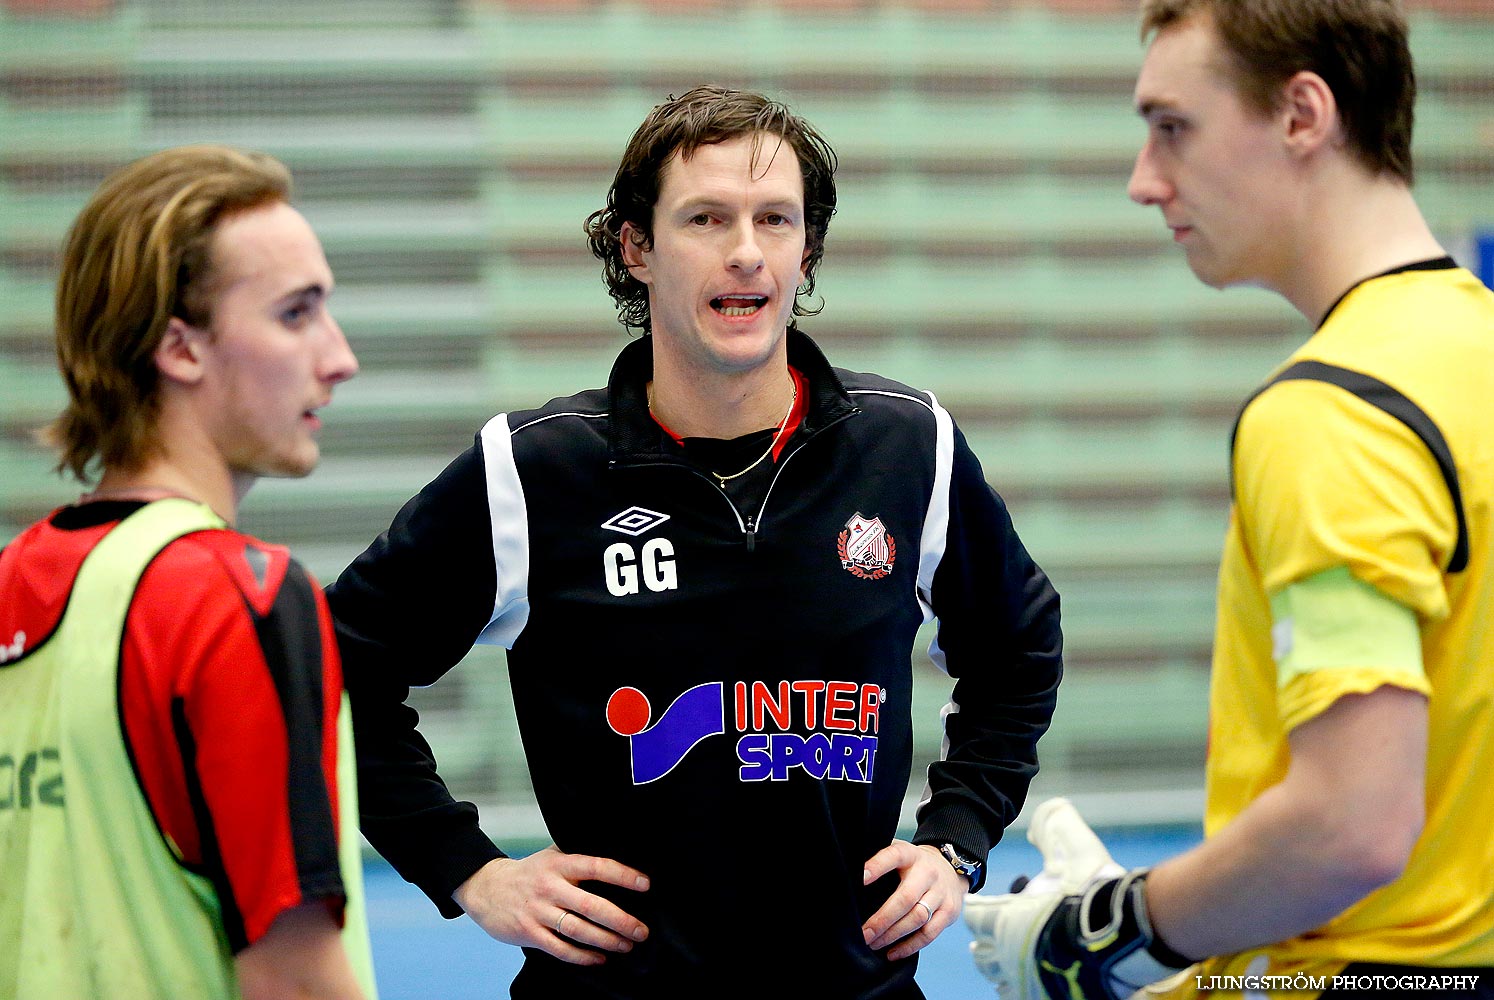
[965,0,1494,997]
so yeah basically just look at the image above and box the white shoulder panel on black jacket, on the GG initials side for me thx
[477,413,529,647]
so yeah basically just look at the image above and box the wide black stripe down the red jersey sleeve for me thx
[249,561,341,897]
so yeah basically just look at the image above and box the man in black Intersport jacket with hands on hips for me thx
[329,88,1062,1000]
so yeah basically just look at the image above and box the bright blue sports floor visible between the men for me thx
[366,827,1201,1000]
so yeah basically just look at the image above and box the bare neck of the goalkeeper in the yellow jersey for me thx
[1276,172,1446,326]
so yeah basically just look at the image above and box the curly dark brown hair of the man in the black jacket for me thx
[586,87,835,333]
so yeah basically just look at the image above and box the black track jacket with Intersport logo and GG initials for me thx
[329,330,1062,1000]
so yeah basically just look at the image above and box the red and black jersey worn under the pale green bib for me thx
[0,502,345,952]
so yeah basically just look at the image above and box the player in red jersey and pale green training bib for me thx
[0,146,374,1000]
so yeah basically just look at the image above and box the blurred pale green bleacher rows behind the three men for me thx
[0,0,1494,819]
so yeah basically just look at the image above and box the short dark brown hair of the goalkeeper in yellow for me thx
[1141,0,1416,184]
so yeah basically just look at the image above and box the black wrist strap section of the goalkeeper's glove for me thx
[1035,868,1192,1000]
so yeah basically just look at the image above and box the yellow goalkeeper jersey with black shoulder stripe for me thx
[1194,259,1494,996]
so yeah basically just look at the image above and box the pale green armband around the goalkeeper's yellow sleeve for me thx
[1271,567,1427,691]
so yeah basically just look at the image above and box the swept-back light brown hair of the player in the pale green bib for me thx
[43,145,290,481]
